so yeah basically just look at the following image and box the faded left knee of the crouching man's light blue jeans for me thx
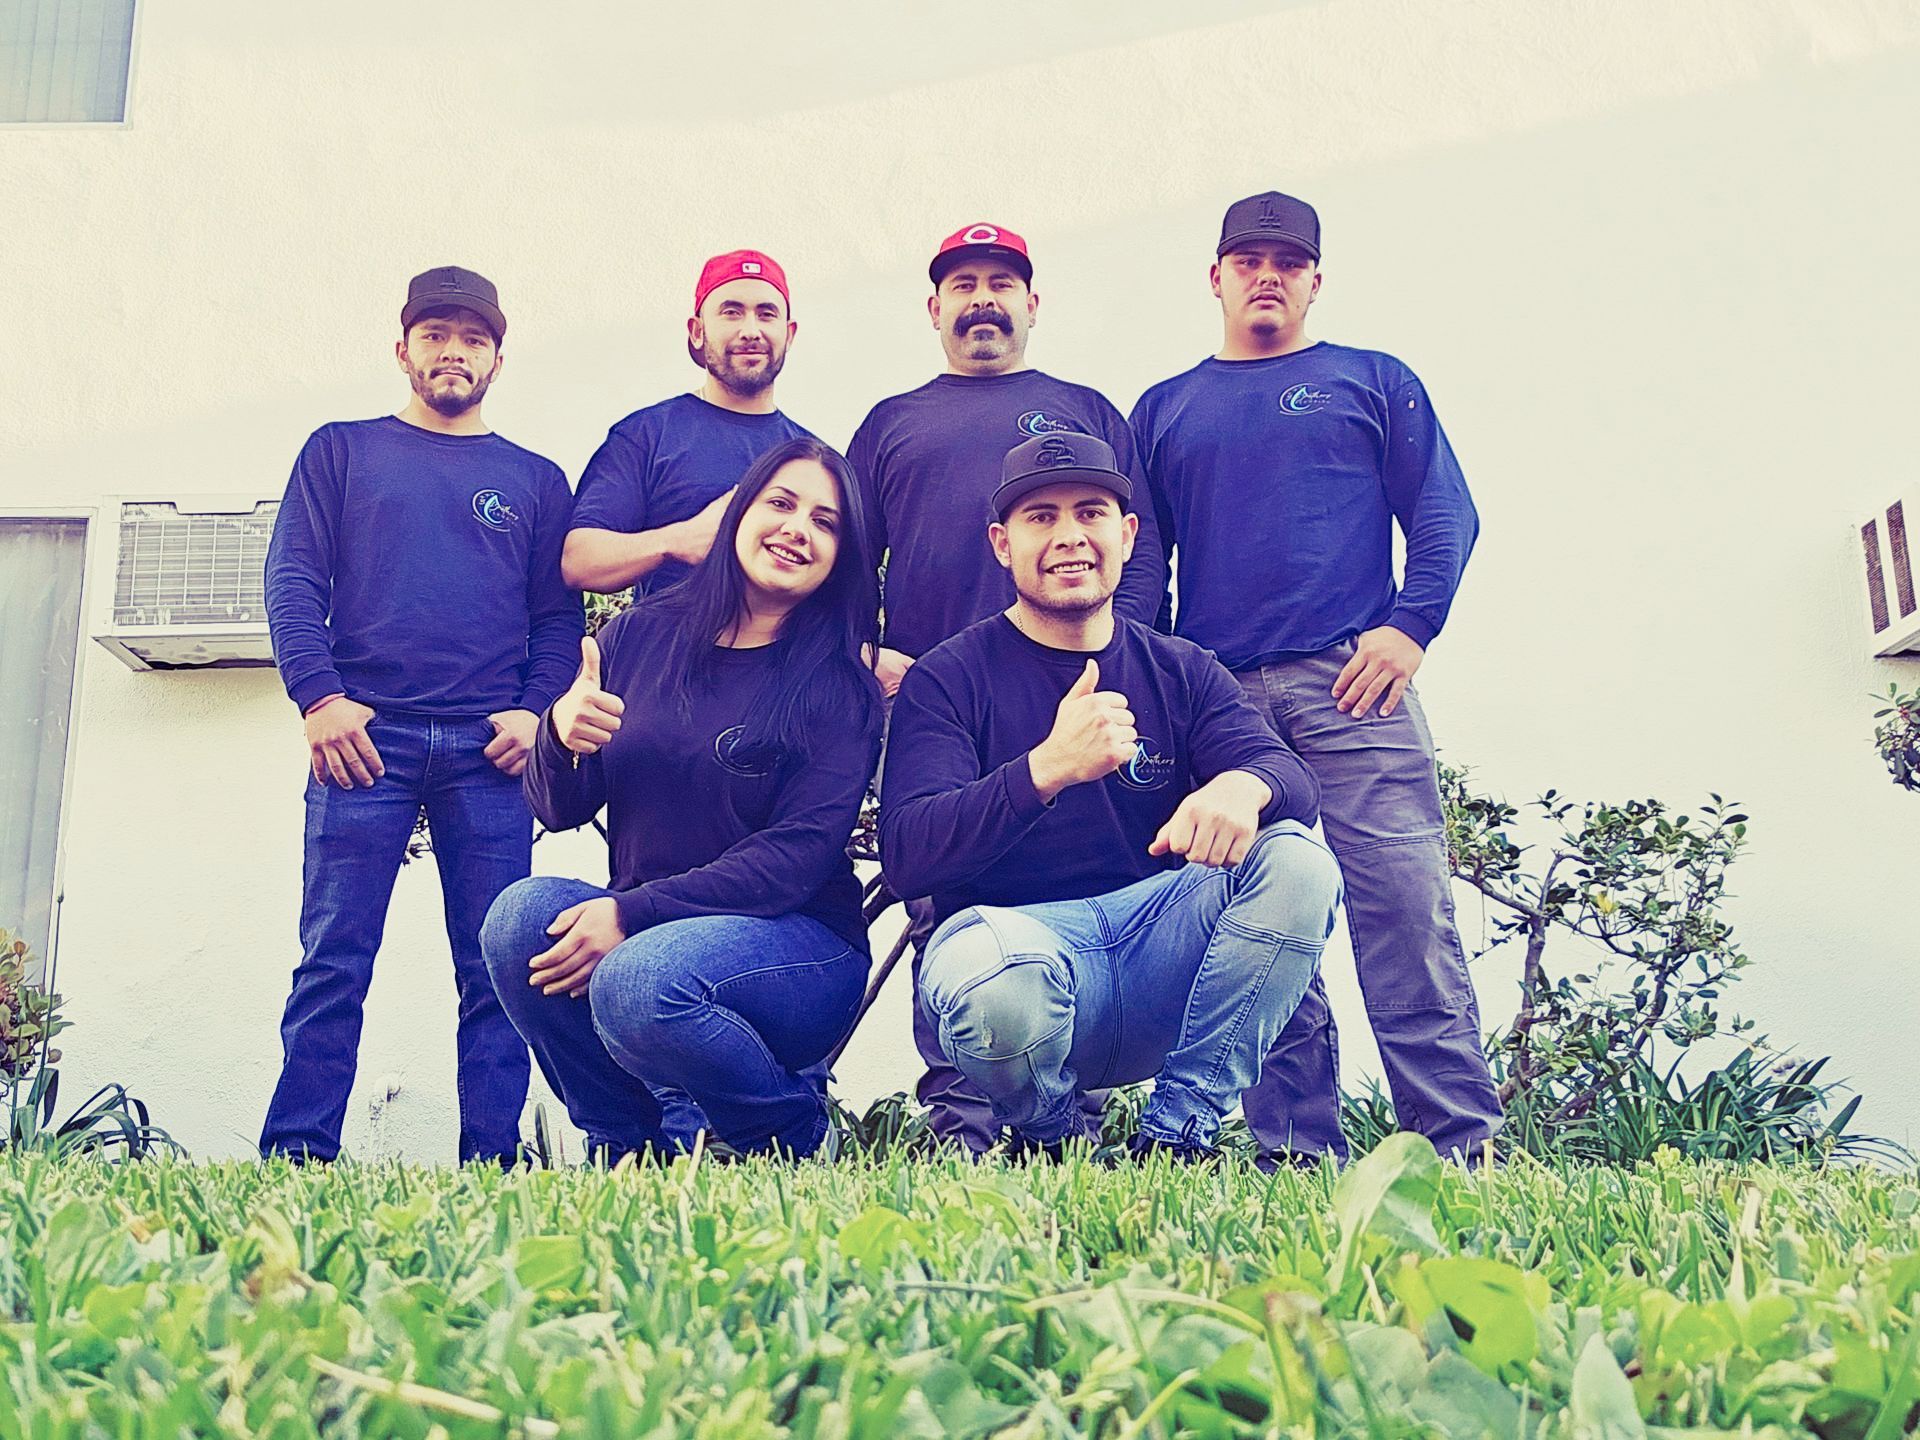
[920,912,1073,1060]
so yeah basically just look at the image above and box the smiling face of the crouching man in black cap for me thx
[987,480,1140,618]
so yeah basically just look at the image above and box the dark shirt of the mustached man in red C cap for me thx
[847,371,1167,657]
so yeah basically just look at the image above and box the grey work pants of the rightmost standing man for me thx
[1236,639,1501,1160]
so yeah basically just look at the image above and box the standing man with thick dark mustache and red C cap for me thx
[847,221,1167,1150]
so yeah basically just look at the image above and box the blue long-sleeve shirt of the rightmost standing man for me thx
[1133,342,1480,670]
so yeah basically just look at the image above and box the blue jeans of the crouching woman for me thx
[480,876,868,1156]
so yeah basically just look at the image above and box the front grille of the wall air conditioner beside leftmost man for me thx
[113,499,280,626]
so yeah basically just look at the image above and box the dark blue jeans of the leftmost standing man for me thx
[259,712,534,1162]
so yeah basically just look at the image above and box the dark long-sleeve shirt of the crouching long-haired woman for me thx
[526,607,879,952]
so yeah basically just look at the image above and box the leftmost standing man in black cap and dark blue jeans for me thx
[259,265,584,1162]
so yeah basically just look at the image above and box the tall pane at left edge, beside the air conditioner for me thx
[0,516,86,975]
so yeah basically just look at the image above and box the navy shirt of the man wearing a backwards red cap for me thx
[574,396,806,593]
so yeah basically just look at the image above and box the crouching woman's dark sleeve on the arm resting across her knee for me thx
[616,726,879,935]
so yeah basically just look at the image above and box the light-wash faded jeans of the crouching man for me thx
[920,820,1340,1144]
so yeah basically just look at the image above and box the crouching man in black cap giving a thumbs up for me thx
[879,434,1340,1156]
